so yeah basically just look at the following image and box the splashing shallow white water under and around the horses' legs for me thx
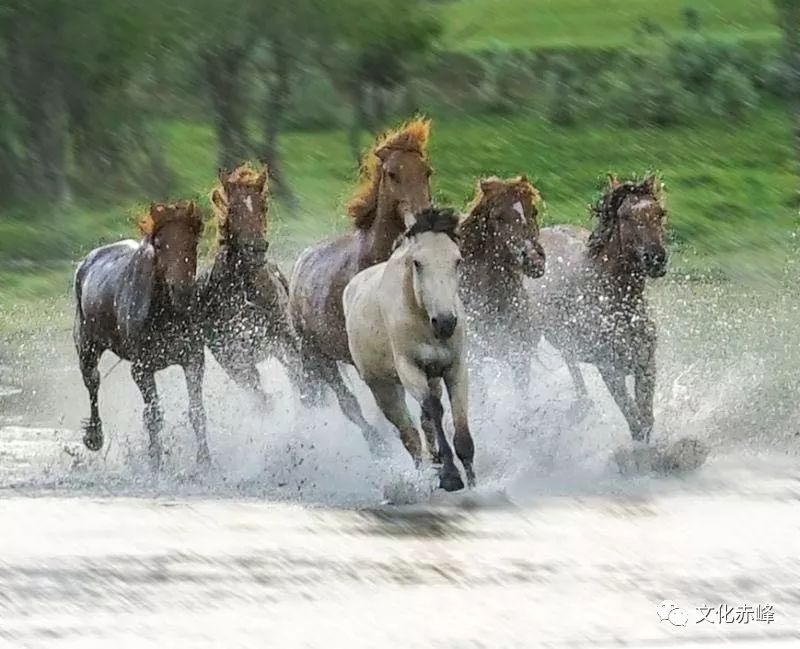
[0,284,800,648]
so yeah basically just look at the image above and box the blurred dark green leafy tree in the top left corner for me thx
[0,0,178,201]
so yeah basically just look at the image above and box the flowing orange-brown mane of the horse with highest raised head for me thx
[347,119,430,230]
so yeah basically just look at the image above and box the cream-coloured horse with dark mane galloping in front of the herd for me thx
[343,208,475,491]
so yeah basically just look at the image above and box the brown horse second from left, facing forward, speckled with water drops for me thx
[198,165,295,409]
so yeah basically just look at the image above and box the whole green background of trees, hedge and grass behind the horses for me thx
[0,0,800,327]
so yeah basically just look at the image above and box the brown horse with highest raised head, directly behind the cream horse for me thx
[289,120,431,444]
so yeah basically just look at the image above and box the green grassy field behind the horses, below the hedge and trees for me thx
[0,103,797,328]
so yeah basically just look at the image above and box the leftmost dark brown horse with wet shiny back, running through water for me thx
[74,202,210,469]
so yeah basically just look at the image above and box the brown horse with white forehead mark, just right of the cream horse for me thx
[459,176,545,396]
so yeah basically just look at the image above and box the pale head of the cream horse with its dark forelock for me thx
[405,208,462,340]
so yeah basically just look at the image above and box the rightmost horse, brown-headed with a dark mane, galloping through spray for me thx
[532,176,667,442]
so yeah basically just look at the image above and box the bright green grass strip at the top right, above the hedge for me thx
[441,0,778,50]
